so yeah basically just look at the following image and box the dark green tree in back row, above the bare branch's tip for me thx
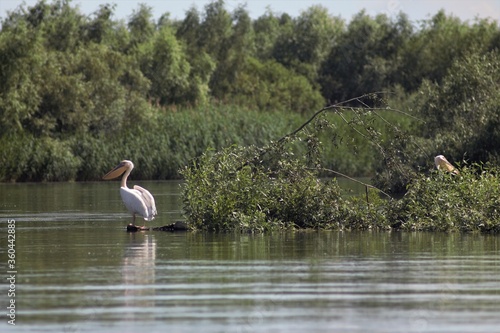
[320,11,412,102]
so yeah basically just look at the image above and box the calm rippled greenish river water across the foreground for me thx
[0,182,500,333]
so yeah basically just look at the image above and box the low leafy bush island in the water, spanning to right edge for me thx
[182,123,500,232]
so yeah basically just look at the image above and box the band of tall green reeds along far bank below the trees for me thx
[0,104,410,181]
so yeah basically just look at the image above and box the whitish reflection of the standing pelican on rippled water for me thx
[122,232,156,321]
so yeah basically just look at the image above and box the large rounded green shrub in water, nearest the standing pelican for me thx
[182,145,348,231]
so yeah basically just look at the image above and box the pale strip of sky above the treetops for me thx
[0,0,500,22]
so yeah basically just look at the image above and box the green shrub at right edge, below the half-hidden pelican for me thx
[388,165,500,232]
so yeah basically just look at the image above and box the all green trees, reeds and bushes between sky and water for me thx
[0,0,500,231]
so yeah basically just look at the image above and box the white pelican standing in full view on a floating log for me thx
[102,160,156,223]
